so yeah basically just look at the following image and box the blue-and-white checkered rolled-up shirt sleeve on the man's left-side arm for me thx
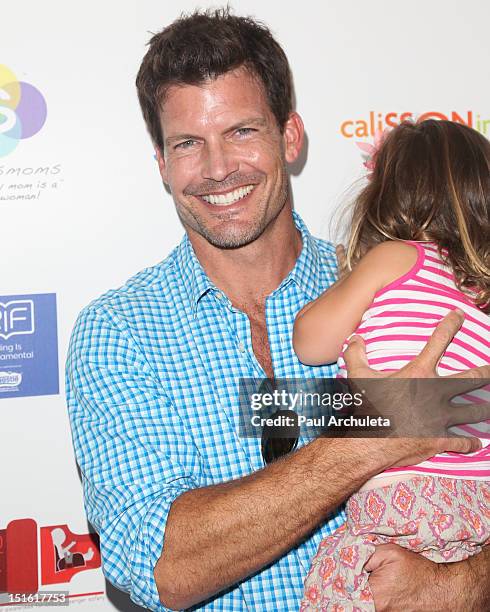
[66,308,201,611]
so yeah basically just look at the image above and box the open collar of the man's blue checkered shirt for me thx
[177,211,330,316]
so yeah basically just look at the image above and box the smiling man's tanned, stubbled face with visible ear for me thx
[157,68,303,248]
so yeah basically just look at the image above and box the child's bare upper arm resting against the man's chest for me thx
[293,241,417,365]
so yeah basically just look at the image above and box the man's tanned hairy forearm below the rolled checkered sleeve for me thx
[155,439,396,609]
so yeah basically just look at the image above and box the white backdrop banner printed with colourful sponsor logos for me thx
[0,0,490,610]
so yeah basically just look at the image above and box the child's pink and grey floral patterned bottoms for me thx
[300,475,490,612]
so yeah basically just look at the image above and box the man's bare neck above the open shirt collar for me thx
[189,203,302,310]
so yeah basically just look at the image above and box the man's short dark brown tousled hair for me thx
[136,8,293,152]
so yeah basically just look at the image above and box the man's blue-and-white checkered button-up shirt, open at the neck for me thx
[66,213,344,611]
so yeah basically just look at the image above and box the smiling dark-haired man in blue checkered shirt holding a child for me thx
[67,11,489,611]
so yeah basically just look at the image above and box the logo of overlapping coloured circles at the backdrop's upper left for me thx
[0,64,48,157]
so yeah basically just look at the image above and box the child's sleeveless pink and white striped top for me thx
[339,242,490,480]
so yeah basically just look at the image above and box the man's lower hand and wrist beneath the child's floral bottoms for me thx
[365,544,490,612]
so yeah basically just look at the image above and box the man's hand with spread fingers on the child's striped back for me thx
[345,311,490,467]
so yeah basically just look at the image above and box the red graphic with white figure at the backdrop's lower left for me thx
[0,518,100,593]
